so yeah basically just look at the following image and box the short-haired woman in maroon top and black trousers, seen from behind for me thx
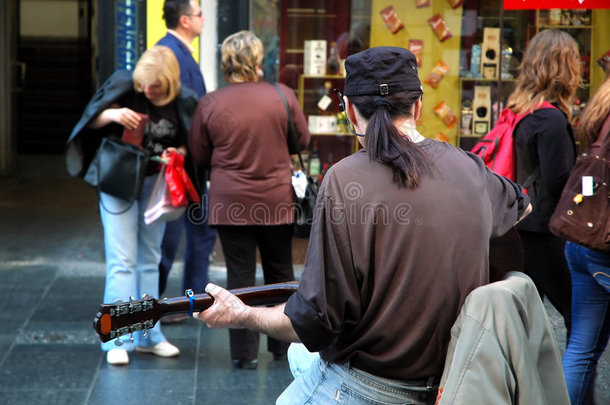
[188,31,310,369]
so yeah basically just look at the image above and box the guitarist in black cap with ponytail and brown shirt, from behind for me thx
[191,47,530,405]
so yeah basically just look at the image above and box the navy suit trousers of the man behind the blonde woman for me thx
[159,204,216,297]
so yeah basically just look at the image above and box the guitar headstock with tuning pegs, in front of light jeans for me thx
[93,296,163,342]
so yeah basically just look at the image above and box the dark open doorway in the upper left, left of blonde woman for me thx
[17,0,93,153]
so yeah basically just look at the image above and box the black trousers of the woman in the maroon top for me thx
[216,224,294,360]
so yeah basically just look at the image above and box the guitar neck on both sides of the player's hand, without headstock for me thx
[158,282,299,316]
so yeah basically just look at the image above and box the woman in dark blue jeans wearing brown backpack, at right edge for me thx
[563,76,610,405]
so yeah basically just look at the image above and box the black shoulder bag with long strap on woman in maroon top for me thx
[273,83,318,238]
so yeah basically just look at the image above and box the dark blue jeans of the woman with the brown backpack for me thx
[563,242,610,405]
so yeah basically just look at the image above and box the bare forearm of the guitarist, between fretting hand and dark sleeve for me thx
[243,304,300,342]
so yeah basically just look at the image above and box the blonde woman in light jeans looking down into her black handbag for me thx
[67,46,197,365]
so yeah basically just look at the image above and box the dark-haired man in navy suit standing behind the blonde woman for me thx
[157,0,216,323]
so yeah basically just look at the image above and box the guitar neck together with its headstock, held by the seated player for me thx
[93,281,299,342]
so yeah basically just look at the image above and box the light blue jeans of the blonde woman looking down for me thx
[100,175,165,351]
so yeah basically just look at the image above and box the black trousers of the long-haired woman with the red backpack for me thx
[519,230,572,339]
